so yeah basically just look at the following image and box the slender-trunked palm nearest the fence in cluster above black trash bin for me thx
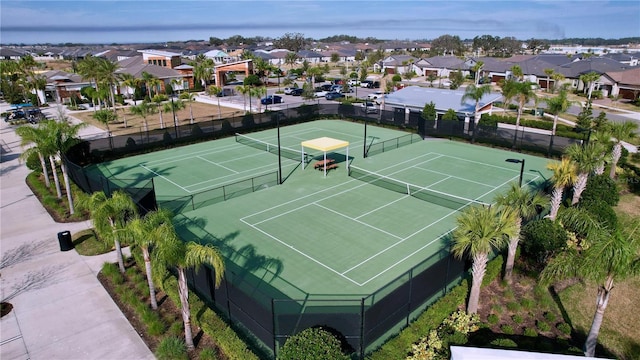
[45,114,87,215]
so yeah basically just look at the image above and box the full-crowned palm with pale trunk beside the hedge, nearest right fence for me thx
[451,206,518,314]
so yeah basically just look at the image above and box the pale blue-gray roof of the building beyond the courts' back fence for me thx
[384,86,502,114]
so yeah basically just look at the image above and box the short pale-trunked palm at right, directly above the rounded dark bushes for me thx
[564,141,604,205]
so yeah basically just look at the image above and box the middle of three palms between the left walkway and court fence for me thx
[124,209,173,310]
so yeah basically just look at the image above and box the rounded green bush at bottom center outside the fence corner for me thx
[278,327,349,360]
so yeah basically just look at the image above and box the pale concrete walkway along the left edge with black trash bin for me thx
[0,103,154,360]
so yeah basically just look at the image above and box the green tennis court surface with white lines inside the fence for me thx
[87,120,550,299]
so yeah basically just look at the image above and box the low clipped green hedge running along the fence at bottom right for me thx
[367,255,503,360]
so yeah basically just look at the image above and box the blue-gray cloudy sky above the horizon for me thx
[0,0,640,44]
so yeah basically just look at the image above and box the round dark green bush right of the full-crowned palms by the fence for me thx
[522,219,567,265]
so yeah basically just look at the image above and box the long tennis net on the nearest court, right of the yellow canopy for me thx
[349,165,491,211]
